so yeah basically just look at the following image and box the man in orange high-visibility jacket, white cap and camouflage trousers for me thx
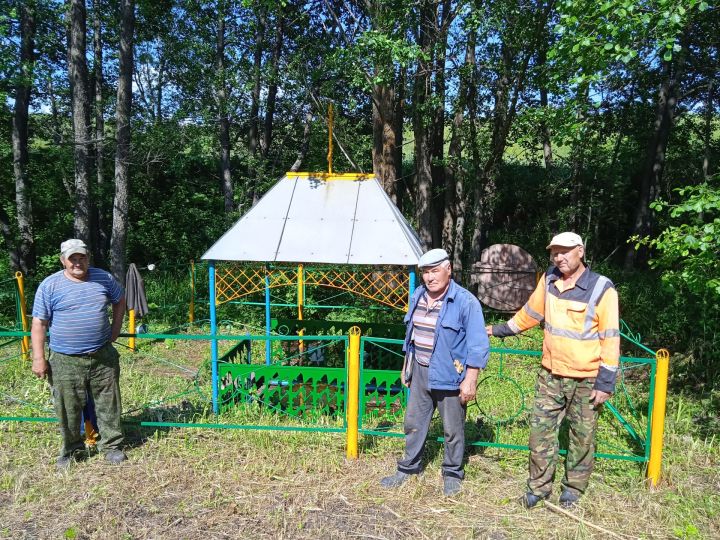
[486,232,620,508]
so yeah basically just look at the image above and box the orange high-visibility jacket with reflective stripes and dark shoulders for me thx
[500,267,620,380]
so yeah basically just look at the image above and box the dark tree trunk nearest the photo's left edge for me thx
[12,4,35,274]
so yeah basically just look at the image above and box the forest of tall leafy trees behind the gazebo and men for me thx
[0,0,720,384]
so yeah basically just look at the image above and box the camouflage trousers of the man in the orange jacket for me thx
[528,368,598,497]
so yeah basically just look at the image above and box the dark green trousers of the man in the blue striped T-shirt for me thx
[49,343,123,457]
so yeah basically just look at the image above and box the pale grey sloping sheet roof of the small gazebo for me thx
[202,173,422,265]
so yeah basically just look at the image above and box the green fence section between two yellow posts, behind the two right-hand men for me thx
[359,337,655,461]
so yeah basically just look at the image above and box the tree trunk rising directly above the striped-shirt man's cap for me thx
[68,0,92,245]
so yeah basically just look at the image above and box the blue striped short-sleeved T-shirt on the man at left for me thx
[33,268,123,354]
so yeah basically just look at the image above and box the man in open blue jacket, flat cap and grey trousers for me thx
[380,249,490,496]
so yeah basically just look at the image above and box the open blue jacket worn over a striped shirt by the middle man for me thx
[403,280,490,390]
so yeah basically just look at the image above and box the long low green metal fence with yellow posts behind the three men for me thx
[0,268,669,486]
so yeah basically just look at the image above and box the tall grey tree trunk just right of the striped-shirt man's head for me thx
[110,0,135,283]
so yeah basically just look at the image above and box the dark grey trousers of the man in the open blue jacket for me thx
[398,363,466,479]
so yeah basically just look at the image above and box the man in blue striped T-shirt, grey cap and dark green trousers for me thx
[31,239,127,470]
